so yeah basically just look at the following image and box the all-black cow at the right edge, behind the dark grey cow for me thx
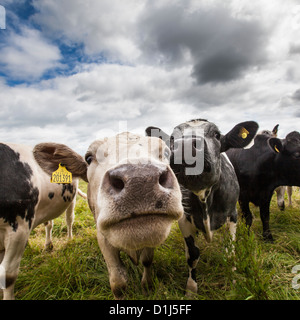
[226,131,300,242]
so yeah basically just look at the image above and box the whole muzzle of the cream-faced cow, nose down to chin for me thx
[97,163,183,250]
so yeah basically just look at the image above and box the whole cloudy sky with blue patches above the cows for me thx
[0,0,300,154]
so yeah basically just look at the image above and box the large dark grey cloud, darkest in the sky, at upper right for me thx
[139,5,268,84]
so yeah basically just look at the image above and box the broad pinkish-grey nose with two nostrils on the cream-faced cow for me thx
[102,164,175,194]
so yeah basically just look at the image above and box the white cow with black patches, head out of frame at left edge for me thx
[0,143,86,300]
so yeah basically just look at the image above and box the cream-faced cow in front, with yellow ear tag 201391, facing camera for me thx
[34,132,183,299]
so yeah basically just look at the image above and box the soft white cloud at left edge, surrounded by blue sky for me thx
[0,27,62,80]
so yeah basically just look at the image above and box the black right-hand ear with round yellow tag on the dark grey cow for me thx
[221,121,258,152]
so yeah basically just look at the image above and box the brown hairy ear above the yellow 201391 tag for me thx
[33,142,88,182]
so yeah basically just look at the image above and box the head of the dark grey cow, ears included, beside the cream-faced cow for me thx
[146,119,258,199]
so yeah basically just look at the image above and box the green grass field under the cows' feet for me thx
[15,183,300,300]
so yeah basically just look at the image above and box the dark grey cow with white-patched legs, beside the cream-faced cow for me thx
[146,119,258,296]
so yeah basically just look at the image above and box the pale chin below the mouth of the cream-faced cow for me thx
[103,214,174,250]
